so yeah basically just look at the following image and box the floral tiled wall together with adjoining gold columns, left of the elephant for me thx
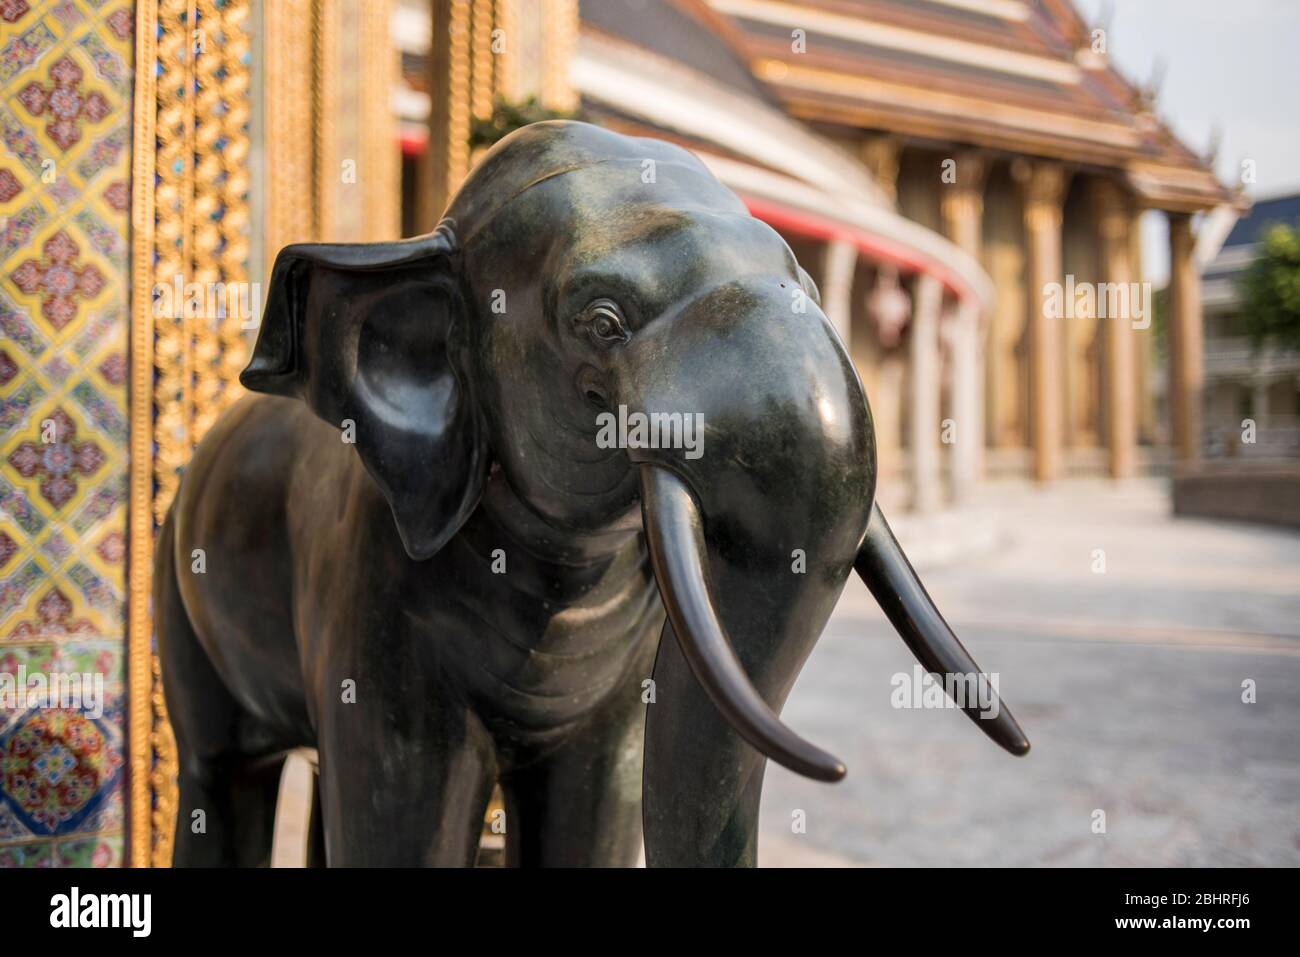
[0,0,399,867]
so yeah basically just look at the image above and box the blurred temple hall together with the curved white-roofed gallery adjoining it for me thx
[405,0,1243,508]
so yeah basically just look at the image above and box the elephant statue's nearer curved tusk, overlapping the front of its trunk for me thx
[641,464,845,781]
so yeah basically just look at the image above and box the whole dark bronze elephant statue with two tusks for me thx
[153,122,1028,866]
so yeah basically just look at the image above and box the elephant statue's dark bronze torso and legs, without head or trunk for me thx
[157,395,663,865]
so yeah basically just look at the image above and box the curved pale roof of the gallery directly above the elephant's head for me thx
[569,0,993,309]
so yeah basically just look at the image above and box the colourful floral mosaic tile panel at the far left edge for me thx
[0,0,134,867]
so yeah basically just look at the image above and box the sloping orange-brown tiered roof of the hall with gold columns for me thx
[707,0,1232,211]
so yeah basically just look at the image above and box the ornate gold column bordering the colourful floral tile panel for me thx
[127,0,252,867]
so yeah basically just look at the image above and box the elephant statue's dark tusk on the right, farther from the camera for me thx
[854,505,1030,754]
